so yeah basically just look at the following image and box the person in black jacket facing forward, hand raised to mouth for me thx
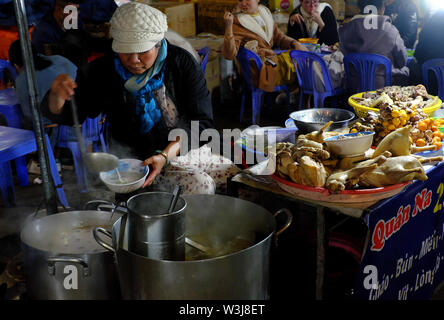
[287,0,339,46]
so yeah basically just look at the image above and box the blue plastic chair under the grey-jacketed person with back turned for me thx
[344,53,392,92]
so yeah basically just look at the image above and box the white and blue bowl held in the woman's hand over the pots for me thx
[100,159,150,193]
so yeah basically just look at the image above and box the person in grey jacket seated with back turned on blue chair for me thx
[339,0,409,92]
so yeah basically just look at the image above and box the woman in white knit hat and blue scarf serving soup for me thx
[42,2,237,193]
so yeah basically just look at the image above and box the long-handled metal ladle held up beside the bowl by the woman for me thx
[71,95,119,173]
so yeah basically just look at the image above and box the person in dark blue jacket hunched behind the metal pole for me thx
[9,40,77,150]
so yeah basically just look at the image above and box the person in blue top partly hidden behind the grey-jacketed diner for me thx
[384,0,418,49]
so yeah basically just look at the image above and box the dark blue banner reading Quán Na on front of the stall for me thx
[355,163,444,300]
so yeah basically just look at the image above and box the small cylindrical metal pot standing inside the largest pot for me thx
[126,192,187,260]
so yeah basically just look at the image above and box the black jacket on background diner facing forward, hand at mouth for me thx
[287,5,339,46]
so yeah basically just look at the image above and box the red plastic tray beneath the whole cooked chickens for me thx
[272,174,411,205]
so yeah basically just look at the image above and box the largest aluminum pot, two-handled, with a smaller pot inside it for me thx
[94,195,292,300]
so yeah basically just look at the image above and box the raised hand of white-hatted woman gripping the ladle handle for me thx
[49,74,77,114]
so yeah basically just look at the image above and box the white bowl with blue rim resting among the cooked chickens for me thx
[324,131,375,158]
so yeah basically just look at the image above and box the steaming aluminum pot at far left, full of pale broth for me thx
[20,211,120,300]
